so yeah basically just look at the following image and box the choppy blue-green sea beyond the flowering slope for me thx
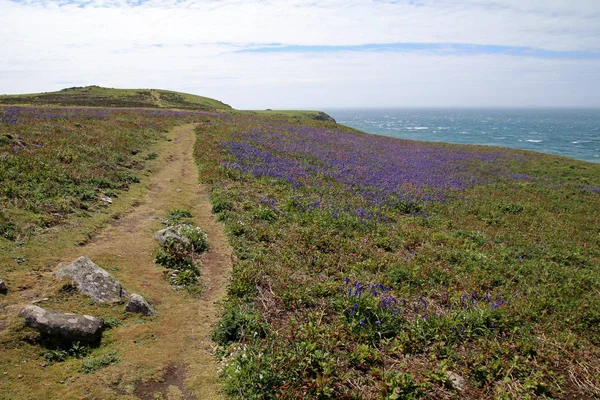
[324,109,600,163]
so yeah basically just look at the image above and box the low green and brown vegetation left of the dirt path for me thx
[0,107,216,240]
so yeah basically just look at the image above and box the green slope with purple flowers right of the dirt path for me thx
[196,115,600,399]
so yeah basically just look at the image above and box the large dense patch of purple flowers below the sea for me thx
[225,122,523,216]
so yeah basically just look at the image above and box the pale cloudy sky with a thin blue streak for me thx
[0,0,600,109]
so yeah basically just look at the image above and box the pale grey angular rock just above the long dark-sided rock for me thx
[56,257,129,303]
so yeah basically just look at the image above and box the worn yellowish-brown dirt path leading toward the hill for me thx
[62,125,231,399]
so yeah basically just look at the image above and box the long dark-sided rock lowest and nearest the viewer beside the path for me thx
[21,305,104,343]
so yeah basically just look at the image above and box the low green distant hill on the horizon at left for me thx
[0,86,232,110]
